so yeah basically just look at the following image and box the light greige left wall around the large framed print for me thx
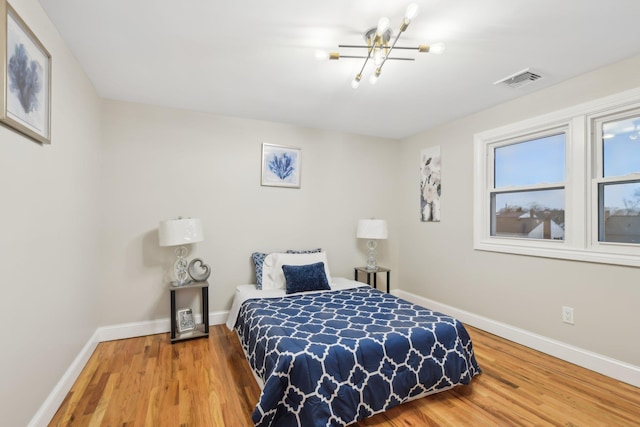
[0,0,101,426]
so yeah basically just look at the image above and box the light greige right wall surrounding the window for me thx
[398,57,640,366]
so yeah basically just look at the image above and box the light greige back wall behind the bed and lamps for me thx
[99,101,398,325]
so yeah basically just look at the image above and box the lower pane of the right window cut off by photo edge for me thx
[599,181,640,243]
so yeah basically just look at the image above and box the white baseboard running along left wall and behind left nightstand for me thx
[28,311,229,427]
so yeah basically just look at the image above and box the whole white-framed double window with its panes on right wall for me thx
[474,89,640,266]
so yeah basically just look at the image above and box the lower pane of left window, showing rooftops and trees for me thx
[491,189,564,240]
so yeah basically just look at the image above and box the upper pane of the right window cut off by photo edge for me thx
[602,117,640,177]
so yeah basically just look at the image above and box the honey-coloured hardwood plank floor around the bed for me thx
[49,325,640,427]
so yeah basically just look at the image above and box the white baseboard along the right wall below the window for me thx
[392,290,640,387]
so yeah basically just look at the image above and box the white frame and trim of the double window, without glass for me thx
[474,88,640,267]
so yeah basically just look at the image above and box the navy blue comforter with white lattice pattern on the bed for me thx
[236,287,480,427]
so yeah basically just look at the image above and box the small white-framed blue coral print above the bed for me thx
[261,144,302,188]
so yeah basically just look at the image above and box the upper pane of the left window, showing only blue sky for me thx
[494,133,565,188]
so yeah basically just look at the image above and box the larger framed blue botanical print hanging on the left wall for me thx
[0,0,51,144]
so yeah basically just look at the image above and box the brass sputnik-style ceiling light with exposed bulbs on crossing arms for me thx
[328,3,444,89]
